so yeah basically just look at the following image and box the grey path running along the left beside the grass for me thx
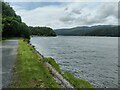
[0,39,18,88]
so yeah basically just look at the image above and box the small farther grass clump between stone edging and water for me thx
[44,57,62,74]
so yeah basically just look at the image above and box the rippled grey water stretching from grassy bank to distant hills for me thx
[30,36,118,88]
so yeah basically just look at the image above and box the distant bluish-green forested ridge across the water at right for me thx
[55,25,120,37]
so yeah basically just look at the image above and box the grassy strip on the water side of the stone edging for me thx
[45,57,95,90]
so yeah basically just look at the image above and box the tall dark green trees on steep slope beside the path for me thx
[2,2,30,38]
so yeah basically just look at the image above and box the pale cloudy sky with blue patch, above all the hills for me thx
[5,0,118,29]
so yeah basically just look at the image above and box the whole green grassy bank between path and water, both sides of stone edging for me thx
[10,39,95,89]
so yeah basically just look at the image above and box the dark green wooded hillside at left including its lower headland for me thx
[0,1,56,38]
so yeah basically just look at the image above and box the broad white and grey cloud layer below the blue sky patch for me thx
[18,2,120,28]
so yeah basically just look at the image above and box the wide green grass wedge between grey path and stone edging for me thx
[11,39,60,88]
